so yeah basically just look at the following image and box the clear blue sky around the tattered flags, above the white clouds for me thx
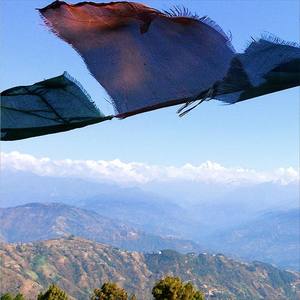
[0,0,300,169]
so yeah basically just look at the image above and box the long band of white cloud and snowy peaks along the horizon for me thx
[1,151,299,184]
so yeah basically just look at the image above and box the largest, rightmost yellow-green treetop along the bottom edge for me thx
[152,276,205,300]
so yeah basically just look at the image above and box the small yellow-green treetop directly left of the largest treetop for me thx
[91,282,128,300]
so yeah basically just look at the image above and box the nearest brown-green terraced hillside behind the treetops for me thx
[0,238,300,300]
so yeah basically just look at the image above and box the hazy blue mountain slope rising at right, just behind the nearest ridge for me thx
[205,209,300,270]
